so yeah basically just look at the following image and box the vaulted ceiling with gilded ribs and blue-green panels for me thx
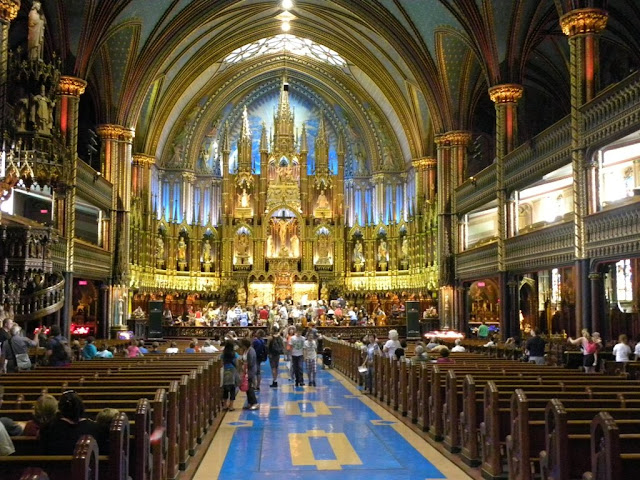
[11,0,640,172]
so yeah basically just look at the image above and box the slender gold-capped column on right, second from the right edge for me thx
[489,84,523,336]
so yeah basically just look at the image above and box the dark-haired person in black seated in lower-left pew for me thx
[40,390,102,455]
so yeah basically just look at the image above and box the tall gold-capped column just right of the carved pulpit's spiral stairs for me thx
[55,76,87,334]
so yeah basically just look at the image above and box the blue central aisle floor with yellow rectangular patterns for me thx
[194,362,470,480]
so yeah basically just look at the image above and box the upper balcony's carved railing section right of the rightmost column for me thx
[580,72,640,147]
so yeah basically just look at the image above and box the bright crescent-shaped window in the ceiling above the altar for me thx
[223,33,347,67]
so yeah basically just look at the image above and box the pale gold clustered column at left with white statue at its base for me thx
[97,124,134,334]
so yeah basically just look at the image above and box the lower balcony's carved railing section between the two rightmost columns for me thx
[505,222,574,270]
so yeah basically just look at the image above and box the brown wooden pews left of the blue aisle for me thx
[0,354,221,480]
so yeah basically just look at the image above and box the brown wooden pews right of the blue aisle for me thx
[325,339,640,480]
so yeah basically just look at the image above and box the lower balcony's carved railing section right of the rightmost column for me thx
[585,202,640,258]
